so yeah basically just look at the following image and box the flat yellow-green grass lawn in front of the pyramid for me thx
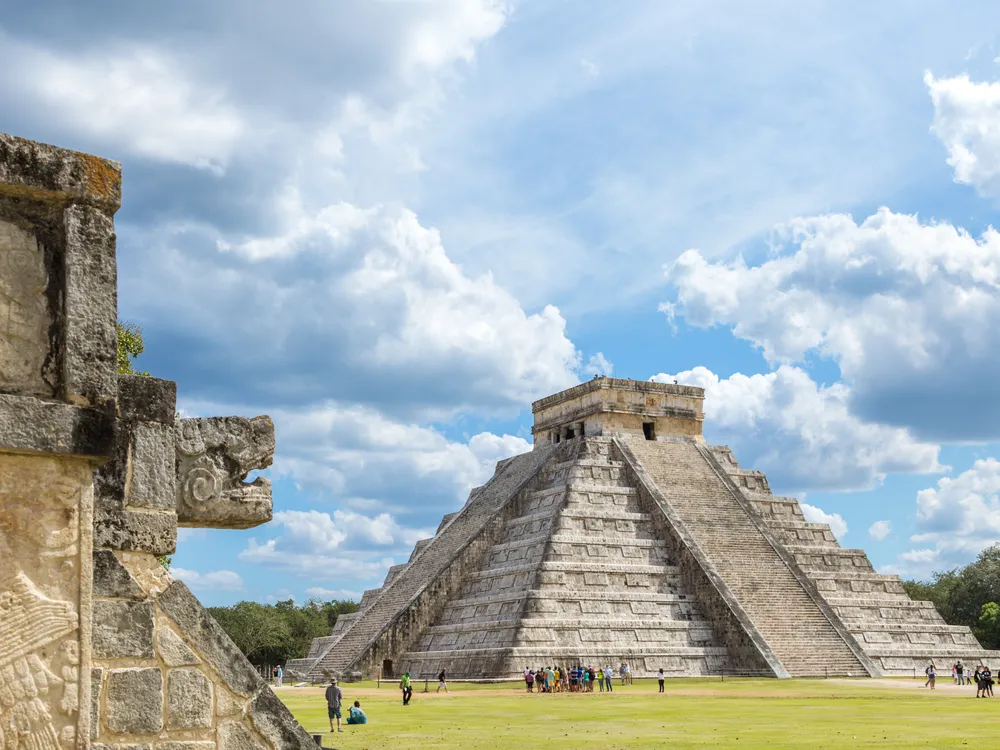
[277,679,1000,750]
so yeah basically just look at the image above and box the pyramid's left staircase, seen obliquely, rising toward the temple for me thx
[309,448,565,680]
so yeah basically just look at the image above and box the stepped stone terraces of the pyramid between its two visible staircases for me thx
[403,438,726,678]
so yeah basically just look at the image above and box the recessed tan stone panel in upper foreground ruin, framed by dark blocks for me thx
[0,221,52,395]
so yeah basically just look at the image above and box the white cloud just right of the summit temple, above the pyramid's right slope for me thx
[652,365,943,492]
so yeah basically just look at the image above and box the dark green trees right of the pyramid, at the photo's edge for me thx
[903,544,1000,649]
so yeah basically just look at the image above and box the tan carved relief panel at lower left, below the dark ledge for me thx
[0,455,91,750]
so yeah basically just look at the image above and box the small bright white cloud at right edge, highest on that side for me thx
[924,71,1000,198]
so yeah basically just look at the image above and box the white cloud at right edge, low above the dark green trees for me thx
[899,458,1000,576]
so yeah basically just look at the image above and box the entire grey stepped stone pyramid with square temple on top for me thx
[286,377,1000,681]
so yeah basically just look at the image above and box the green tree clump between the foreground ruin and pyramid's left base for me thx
[208,599,358,666]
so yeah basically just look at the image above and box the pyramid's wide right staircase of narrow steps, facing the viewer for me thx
[621,437,868,677]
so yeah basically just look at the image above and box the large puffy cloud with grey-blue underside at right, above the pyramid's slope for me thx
[661,208,1000,440]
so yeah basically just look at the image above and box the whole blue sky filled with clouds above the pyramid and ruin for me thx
[0,0,1000,604]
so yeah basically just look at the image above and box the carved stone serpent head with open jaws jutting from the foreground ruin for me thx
[176,417,274,529]
